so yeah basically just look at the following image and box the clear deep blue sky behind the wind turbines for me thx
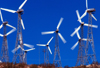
[0,0,100,66]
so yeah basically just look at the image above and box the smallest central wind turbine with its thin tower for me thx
[37,37,53,64]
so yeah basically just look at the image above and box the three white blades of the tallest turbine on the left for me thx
[1,0,27,29]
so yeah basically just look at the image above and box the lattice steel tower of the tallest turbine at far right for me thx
[85,9,97,64]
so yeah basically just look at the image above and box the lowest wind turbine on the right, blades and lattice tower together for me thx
[71,28,87,66]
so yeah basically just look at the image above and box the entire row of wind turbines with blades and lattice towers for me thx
[0,0,98,67]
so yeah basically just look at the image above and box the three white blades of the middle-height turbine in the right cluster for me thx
[71,10,98,36]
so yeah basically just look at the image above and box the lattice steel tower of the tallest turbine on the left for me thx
[13,11,24,63]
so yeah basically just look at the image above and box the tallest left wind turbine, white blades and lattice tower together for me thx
[1,0,27,63]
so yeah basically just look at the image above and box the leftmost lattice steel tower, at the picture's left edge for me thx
[1,21,9,62]
